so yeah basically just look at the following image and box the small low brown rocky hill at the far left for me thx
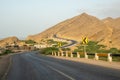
[0,36,19,47]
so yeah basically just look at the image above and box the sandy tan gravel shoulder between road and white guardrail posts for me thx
[49,56,120,70]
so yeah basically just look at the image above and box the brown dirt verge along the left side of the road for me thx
[0,55,10,80]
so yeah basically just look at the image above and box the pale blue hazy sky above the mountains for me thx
[0,0,120,39]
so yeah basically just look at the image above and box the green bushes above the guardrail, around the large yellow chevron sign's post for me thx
[75,41,120,54]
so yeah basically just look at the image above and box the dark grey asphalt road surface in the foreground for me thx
[7,52,120,80]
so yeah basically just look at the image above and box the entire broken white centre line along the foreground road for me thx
[28,54,75,80]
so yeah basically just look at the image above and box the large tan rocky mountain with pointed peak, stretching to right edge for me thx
[27,13,120,48]
